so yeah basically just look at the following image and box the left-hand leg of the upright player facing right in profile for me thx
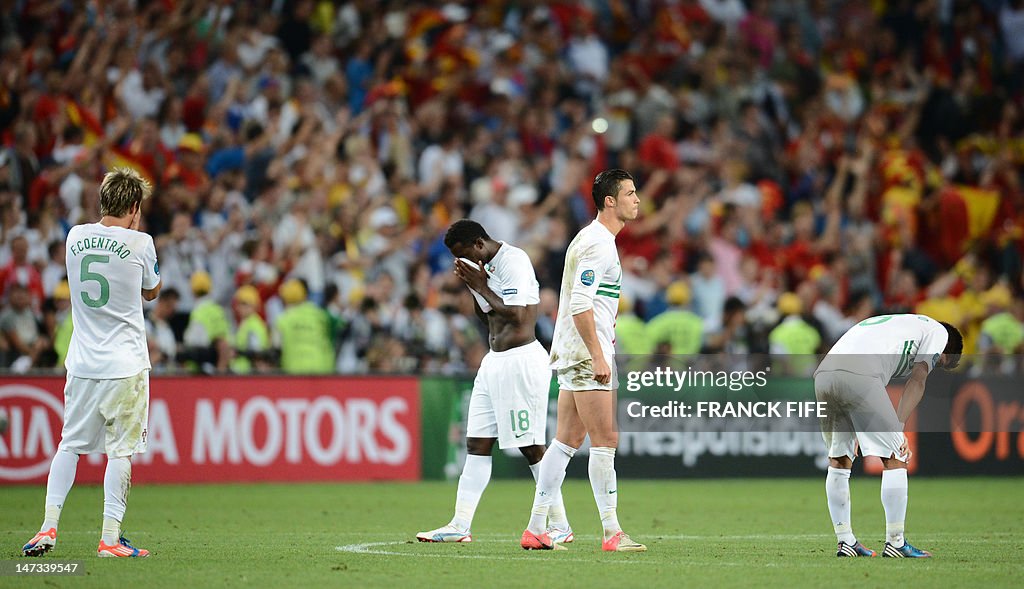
[520,385,587,549]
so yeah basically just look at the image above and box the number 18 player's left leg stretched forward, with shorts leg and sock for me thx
[416,368,498,542]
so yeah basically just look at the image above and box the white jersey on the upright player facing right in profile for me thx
[551,220,623,370]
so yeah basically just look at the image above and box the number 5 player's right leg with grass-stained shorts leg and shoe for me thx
[96,370,150,557]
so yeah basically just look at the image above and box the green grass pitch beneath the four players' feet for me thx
[0,475,1024,589]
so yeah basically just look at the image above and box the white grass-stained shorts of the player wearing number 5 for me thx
[59,370,150,458]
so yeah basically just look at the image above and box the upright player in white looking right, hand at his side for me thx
[520,170,647,552]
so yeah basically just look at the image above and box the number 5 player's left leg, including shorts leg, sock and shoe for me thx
[22,376,104,556]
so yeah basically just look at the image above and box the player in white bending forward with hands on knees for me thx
[814,314,964,558]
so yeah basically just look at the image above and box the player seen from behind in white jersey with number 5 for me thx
[22,168,161,557]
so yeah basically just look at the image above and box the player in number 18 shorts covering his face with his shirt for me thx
[416,219,572,544]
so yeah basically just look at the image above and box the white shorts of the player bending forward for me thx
[814,370,908,462]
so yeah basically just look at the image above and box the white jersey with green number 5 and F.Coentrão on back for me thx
[65,223,160,379]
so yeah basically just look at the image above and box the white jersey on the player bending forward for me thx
[815,314,949,383]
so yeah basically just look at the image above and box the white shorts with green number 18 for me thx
[466,341,551,449]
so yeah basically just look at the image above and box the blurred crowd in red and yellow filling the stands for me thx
[0,0,1024,374]
